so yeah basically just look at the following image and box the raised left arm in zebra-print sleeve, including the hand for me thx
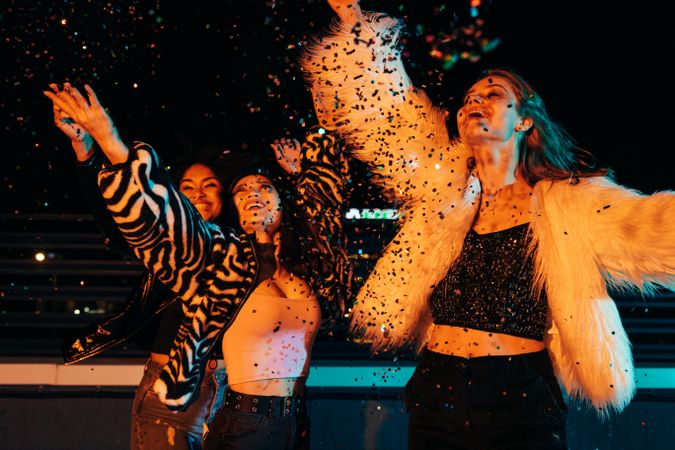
[45,84,213,299]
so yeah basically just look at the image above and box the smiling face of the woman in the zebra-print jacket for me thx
[232,175,281,236]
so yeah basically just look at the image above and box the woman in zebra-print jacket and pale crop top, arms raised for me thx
[45,85,351,449]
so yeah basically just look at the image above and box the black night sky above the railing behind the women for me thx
[0,0,675,218]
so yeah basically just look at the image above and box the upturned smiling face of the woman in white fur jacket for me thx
[457,76,531,145]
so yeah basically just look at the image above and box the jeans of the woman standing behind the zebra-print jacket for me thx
[131,360,225,450]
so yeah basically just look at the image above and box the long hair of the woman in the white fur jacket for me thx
[478,68,609,186]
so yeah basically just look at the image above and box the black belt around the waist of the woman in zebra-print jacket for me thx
[222,389,305,417]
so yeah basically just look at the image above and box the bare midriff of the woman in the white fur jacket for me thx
[426,325,545,358]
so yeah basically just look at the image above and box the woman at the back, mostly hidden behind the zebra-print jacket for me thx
[52,93,234,450]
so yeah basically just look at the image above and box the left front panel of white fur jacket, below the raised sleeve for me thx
[351,171,480,351]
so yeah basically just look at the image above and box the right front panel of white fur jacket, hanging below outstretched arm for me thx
[531,178,648,417]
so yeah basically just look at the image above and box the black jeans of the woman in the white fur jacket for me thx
[403,350,567,450]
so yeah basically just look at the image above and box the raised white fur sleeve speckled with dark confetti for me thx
[301,13,466,200]
